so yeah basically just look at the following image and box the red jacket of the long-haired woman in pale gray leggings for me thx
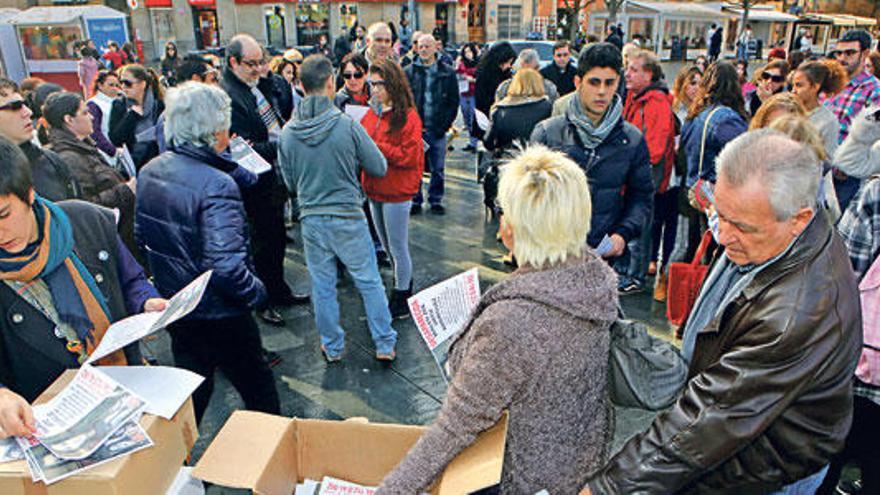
[361,108,425,203]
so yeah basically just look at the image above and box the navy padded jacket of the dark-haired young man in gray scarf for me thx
[532,115,654,247]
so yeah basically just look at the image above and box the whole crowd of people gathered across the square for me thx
[0,22,880,494]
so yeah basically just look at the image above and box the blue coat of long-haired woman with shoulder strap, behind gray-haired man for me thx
[681,106,749,187]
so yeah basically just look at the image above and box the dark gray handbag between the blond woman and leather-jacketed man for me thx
[608,312,688,411]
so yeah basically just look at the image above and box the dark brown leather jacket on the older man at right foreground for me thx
[589,211,862,495]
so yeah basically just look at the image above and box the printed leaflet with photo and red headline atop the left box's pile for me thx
[33,365,146,460]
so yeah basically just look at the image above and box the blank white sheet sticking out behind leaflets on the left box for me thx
[100,366,205,420]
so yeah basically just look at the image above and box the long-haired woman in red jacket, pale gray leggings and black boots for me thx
[361,59,425,318]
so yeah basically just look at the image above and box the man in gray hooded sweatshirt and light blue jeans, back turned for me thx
[278,55,397,362]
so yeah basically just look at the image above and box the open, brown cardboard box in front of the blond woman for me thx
[193,411,507,495]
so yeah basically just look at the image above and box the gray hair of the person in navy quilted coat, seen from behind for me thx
[165,82,232,146]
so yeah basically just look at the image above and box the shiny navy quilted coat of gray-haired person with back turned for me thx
[135,146,266,319]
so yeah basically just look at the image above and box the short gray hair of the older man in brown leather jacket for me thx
[717,129,822,221]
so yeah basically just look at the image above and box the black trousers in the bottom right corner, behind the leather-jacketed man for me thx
[816,395,880,495]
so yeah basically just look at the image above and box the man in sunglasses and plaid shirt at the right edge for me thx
[825,29,880,210]
